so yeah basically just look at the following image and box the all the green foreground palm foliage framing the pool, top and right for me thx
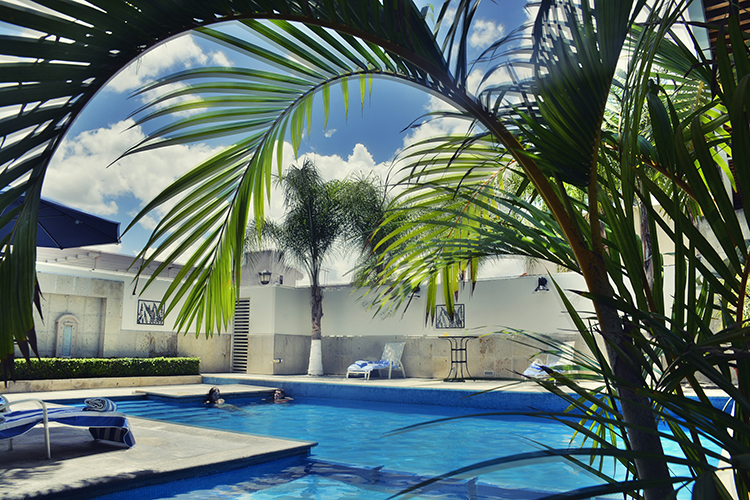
[0,0,750,500]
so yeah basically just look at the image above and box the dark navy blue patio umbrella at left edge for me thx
[0,195,120,249]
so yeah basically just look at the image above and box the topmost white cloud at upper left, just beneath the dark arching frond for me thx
[106,34,231,92]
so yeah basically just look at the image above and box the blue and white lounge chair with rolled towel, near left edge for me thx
[0,394,135,458]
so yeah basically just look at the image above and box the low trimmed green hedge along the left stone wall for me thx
[13,358,200,380]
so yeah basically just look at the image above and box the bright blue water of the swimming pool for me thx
[85,398,712,500]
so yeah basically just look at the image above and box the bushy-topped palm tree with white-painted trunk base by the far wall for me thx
[247,159,384,376]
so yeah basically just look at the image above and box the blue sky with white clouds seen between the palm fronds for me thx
[43,0,527,283]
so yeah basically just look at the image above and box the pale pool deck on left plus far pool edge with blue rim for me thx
[0,374,736,500]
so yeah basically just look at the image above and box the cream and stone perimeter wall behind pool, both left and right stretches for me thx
[27,262,656,378]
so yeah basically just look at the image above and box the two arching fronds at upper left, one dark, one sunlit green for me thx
[0,0,447,373]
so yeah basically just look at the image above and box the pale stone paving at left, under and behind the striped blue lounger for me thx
[0,384,316,500]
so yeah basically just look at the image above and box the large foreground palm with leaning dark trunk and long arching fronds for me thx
[0,0,750,499]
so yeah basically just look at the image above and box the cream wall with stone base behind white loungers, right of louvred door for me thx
[241,273,586,378]
